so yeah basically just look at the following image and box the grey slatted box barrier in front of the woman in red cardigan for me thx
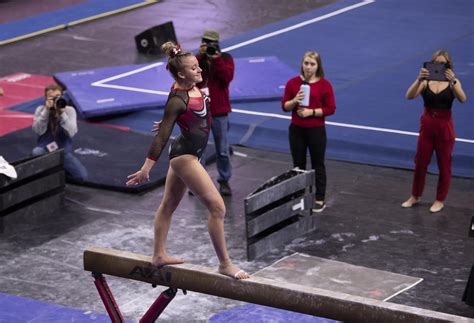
[244,169,316,260]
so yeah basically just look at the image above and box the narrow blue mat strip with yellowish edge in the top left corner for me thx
[0,0,157,45]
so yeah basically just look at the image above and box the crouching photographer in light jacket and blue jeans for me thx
[32,85,87,182]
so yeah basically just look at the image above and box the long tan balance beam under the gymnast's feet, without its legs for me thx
[84,247,472,323]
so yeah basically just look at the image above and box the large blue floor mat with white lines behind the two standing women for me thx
[222,0,474,177]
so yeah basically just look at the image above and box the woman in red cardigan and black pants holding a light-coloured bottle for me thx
[281,51,336,212]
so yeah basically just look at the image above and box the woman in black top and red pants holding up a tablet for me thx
[402,50,467,213]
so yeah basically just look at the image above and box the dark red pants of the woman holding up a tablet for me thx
[412,109,455,201]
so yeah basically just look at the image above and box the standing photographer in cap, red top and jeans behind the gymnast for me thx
[196,30,234,196]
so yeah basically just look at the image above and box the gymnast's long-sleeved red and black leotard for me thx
[148,89,211,160]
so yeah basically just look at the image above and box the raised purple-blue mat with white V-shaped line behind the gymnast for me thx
[54,56,296,118]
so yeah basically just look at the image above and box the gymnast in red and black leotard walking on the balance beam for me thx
[126,42,249,279]
